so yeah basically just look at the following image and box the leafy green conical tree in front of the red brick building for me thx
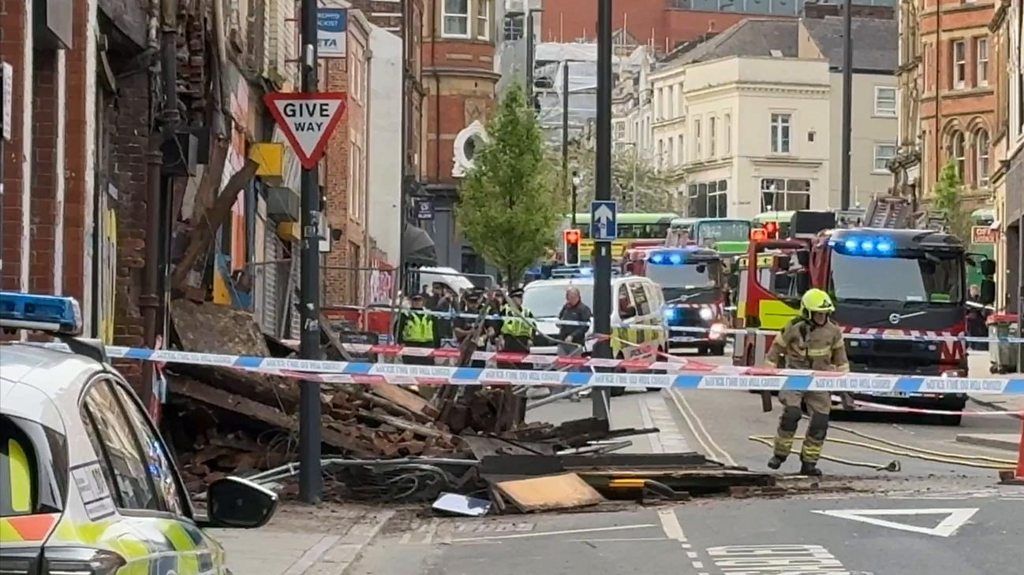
[456,86,561,286]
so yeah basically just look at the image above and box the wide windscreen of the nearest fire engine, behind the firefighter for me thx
[831,252,964,304]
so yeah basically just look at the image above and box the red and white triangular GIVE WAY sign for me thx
[263,92,348,170]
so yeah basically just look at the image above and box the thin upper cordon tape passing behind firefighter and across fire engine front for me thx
[368,308,1024,344]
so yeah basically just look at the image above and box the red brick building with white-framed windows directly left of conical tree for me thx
[413,0,500,269]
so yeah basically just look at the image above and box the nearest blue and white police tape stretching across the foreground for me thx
[36,344,1024,395]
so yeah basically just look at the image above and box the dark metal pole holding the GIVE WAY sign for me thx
[299,0,323,504]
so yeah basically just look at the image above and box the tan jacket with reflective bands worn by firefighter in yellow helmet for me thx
[767,317,850,371]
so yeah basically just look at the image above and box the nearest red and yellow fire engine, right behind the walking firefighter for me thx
[733,197,995,425]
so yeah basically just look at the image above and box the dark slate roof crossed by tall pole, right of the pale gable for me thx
[802,16,899,73]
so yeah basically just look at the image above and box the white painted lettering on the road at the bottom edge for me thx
[708,545,850,575]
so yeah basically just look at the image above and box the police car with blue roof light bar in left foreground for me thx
[0,293,278,575]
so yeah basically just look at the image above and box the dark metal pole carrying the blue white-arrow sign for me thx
[591,0,611,419]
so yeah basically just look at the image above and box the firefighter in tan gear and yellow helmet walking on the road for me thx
[767,290,850,476]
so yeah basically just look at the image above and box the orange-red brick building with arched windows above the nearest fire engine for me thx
[896,0,1002,203]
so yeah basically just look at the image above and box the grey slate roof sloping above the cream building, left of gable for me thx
[666,18,800,67]
